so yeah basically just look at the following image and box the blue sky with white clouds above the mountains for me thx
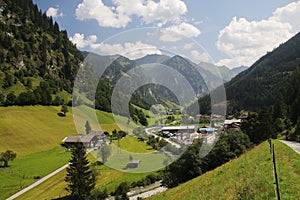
[34,0,300,68]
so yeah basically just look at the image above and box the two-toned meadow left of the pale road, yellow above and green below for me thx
[0,106,138,199]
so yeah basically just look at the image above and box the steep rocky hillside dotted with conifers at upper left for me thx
[0,0,83,105]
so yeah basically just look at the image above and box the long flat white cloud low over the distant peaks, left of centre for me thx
[69,33,161,59]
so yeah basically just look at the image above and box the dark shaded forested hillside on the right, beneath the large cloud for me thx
[226,33,300,110]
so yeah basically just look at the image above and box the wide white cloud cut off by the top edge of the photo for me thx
[75,0,187,28]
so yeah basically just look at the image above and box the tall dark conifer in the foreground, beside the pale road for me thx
[65,142,96,199]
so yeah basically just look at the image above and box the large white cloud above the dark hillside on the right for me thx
[216,2,300,67]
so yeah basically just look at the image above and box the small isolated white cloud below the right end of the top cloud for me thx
[160,22,201,42]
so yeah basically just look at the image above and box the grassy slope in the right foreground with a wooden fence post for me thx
[150,141,300,200]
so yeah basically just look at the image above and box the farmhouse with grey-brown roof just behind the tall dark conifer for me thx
[62,131,106,147]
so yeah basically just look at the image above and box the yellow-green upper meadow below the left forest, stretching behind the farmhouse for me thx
[0,106,134,157]
